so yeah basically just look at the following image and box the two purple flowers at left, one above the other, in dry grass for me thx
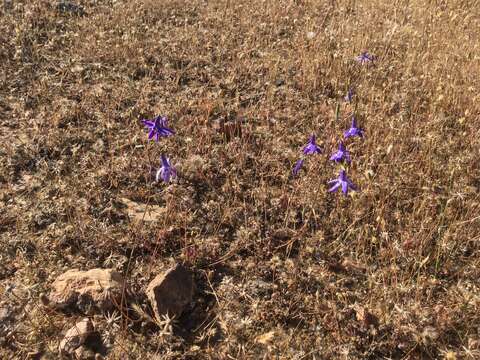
[142,115,177,183]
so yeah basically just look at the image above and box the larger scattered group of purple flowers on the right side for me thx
[292,51,375,195]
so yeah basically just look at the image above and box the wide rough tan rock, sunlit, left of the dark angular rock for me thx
[50,269,124,312]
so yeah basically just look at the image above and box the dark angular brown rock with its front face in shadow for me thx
[147,264,194,319]
